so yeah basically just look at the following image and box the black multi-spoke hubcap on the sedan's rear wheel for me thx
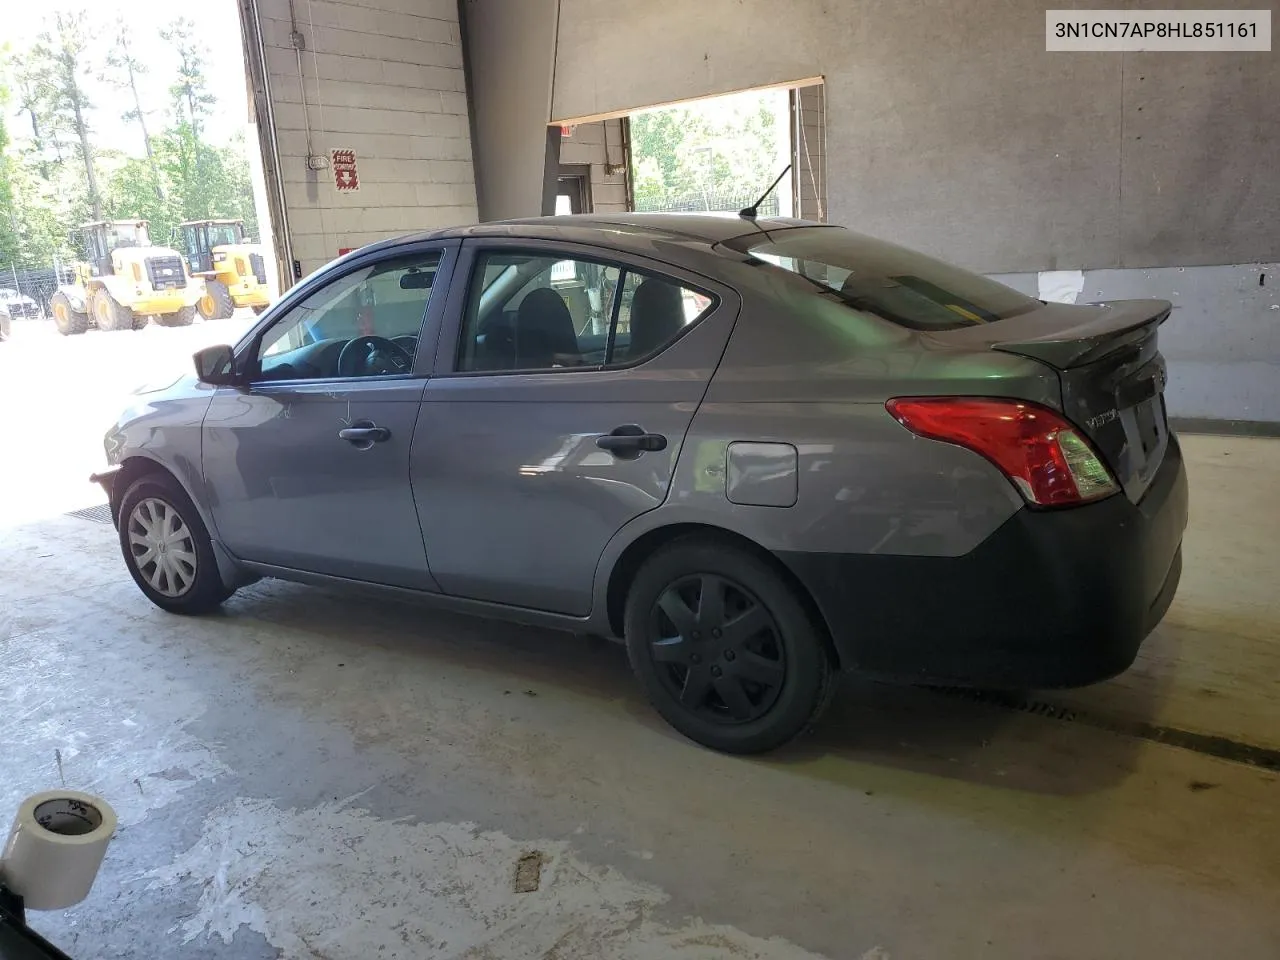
[649,573,786,723]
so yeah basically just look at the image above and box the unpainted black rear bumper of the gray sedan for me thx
[781,436,1187,689]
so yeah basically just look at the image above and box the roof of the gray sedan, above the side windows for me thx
[355,212,826,259]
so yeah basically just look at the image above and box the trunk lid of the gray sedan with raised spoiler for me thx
[937,300,1172,503]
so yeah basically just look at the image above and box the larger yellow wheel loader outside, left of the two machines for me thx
[49,220,205,337]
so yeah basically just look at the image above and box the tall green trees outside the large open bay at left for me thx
[0,13,261,271]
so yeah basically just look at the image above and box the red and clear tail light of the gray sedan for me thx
[884,397,1119,507]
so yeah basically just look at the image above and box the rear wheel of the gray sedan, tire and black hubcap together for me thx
[625,536,835,754]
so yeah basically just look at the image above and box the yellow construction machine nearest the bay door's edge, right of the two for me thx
[178,220,271,320]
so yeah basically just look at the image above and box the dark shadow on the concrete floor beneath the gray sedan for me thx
[209,581,1177,796]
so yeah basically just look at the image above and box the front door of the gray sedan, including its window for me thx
[202,243,456,590]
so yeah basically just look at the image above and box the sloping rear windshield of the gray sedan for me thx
[732,227,1039,330]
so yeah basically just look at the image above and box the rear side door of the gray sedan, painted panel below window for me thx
[410,244,737,616]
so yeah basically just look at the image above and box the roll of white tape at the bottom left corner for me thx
[0,790,115,910]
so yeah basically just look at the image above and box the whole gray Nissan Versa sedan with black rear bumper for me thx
[95,214,1187,753]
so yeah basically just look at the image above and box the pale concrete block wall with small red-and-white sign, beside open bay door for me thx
[259,0,477,275]
